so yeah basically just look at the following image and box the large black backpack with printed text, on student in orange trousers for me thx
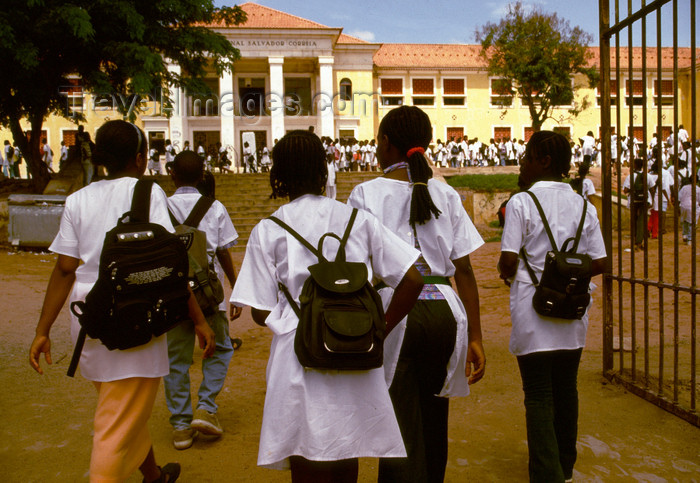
[68,180,190,377]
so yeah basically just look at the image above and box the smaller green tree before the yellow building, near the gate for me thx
[476,2,599,131]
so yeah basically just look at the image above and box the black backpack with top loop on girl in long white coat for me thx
[269,209,386,370]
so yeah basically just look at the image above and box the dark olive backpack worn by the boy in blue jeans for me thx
[168,196,224,315]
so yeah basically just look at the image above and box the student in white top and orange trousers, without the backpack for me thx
[29,121,214,482]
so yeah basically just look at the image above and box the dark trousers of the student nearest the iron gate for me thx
[518,349,582,483]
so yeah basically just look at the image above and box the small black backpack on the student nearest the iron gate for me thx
[520,191,593,320]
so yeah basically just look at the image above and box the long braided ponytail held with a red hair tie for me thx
[379,106,441,228]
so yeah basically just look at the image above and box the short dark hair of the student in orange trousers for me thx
[91,120,148,174]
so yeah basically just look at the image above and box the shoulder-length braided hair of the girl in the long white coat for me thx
[270,130,328,199]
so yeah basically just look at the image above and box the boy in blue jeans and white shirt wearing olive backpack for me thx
[163,151,241,449]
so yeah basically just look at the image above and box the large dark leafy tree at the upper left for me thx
[0,0,246,190]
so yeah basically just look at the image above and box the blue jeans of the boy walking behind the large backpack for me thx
[163,312,233,429]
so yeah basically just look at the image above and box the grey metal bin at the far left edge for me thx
[7,195,66,248]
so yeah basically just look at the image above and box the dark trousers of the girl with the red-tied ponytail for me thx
[378,300,457,483]
